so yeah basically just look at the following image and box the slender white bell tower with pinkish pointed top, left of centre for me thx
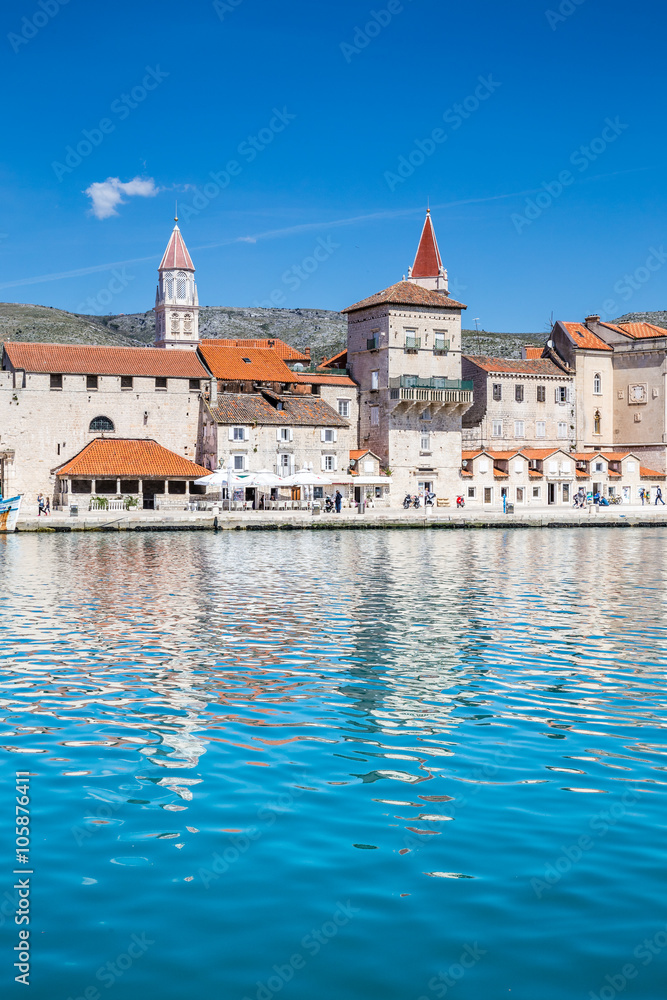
[155,219,199,350]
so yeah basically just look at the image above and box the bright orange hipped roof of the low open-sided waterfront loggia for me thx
[57,438,210,479]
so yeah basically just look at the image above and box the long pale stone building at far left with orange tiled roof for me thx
[0,343,210,502]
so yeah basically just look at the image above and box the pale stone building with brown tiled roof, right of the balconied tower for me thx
[462,355,576,451]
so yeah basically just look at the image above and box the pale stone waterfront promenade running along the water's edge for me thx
[11,506,667,534]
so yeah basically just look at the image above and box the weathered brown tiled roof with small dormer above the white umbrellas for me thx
[208,392,349,427]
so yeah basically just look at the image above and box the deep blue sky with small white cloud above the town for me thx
[0,0,667,332]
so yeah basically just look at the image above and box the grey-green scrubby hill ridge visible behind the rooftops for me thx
[0,302,667,362]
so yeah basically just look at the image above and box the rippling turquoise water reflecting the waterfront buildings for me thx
[0,529,667,1000]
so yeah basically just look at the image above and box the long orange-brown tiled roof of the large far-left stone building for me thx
[4,343,209,378]
